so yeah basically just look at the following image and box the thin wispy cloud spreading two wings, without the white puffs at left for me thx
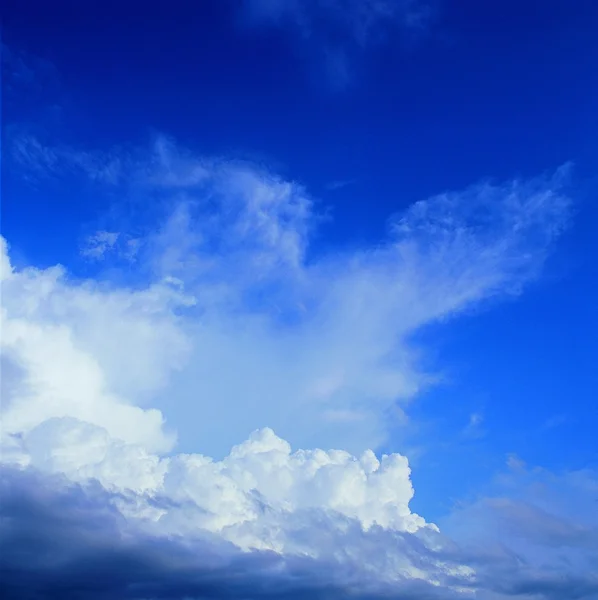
[7,138,569,460]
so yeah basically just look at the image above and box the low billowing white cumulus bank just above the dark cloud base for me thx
[2,418,473,585]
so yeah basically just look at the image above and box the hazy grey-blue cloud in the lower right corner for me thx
[441,464,598,600]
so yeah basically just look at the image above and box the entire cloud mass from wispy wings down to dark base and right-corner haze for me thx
[0,138,598,598]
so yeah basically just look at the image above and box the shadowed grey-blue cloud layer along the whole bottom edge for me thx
[0,467,598,600]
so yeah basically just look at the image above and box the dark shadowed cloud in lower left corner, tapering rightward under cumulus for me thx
[0,467,464,600]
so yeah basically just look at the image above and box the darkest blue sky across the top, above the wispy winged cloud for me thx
[4,0,598,247]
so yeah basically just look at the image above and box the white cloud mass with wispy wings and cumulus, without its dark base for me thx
[1,140,580,590]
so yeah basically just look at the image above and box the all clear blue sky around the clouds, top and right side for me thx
[2,0,598,518]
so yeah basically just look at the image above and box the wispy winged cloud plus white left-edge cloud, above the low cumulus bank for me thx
[4,137,570,457]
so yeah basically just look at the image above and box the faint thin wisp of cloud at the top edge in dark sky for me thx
[241,0,434,88]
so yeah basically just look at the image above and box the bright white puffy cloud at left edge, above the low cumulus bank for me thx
[2,240,191,450]
